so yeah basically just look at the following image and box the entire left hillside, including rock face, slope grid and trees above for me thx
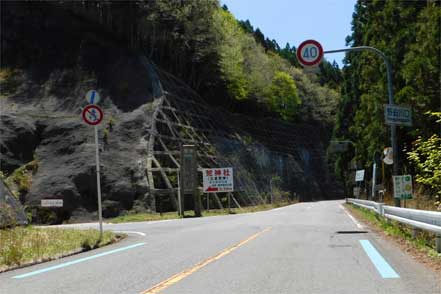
[0,0,341,223]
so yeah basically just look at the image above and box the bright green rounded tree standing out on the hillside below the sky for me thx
[267,72,302,120]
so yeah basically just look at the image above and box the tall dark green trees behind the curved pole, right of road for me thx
[335,0,441,208]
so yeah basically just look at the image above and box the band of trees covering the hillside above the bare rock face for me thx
[2,0,341,128]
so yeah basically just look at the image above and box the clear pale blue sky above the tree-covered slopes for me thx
[220,0,356,67]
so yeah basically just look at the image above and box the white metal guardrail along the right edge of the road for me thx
[346,198,441,253]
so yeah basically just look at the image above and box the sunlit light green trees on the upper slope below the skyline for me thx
[213,10,340,124]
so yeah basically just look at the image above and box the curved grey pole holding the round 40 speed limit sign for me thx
[323,46,401,207]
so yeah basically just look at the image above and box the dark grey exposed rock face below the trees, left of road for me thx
[0,2,342,222]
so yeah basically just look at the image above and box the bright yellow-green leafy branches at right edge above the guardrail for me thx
[407,112,441,209]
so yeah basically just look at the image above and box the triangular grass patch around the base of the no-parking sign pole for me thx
[0,226,122,272]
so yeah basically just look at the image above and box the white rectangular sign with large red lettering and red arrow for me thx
[202,167,234,193]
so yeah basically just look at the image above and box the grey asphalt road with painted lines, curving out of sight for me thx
[0,201,441,294]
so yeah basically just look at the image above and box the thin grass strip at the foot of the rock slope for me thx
[106,201,297,224]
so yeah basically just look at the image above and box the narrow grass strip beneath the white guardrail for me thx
[345,204,441,262]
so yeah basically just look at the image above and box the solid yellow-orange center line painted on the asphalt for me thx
[141,228,271,294]
